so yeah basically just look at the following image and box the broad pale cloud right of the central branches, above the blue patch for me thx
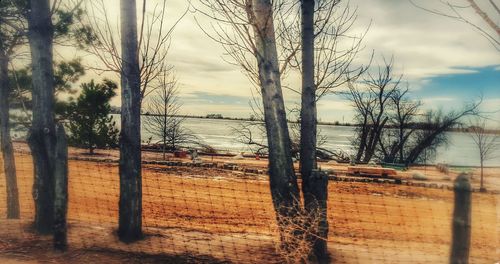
[351,0,500,80]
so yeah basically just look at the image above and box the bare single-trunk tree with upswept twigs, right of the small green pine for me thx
[79,0,187,241]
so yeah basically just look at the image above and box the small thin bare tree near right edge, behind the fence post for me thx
[469,117,500,191]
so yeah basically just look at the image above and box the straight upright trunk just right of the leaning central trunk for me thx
[300,0,328,263]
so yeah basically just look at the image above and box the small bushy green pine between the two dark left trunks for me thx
[63,80,118,154]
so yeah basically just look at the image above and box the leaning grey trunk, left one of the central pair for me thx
[248,0,300,241]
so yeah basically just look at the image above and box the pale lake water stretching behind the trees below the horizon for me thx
[13,115,500,166]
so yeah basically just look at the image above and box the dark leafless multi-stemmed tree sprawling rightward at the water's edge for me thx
[343,59,482,165]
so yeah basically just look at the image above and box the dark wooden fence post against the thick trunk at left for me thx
[54,124,68,251]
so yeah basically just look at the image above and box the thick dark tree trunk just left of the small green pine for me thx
[28,0,56,234]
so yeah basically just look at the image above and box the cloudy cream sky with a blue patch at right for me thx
[75,0,500,124]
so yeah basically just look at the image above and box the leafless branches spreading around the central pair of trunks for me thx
[197,0,368,161]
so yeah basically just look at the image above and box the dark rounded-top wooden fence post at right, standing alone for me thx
[450,174,472,264]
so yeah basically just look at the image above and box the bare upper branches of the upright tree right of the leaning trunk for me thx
[277,0,369,100]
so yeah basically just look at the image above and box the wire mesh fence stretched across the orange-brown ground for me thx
[0,143,500,263]
